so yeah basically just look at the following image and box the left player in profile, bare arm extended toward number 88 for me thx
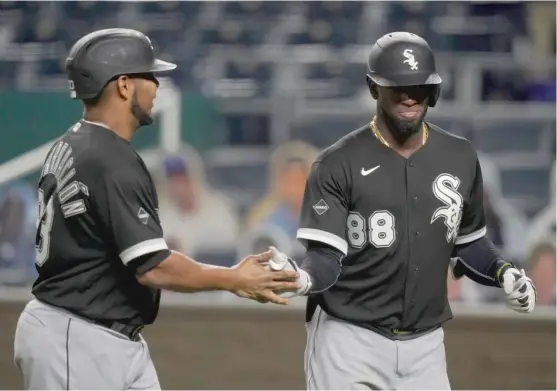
[14,29,298,390]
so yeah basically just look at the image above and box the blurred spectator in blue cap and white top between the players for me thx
[157,147,238,262]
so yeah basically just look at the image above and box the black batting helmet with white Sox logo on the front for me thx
[366,32,442,107]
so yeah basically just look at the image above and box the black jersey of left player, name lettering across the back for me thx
[32,120,169,325]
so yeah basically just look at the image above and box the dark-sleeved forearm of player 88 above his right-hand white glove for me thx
[453,237,512,287]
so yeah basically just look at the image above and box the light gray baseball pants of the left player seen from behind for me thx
[14,299,160,390]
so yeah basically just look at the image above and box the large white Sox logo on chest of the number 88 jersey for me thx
[431,174,463,243]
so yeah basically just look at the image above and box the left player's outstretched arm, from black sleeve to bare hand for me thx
[93,169,298,304]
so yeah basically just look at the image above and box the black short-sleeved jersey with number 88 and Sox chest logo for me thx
[297,125,486,330]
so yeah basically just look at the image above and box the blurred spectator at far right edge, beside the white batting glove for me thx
[527,240,556,305]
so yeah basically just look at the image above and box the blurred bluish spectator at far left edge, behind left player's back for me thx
[0,182,36,285]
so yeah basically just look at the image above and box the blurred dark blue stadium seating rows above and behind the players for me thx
[0,1,555,280]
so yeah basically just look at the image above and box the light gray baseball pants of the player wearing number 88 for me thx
[304,307,450,390]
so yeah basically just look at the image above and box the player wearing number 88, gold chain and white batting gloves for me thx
[272,32,536,390]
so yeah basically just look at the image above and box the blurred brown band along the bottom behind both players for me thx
[0,303,556,390]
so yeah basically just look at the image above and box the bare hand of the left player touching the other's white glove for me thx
[233,251,299,304]
